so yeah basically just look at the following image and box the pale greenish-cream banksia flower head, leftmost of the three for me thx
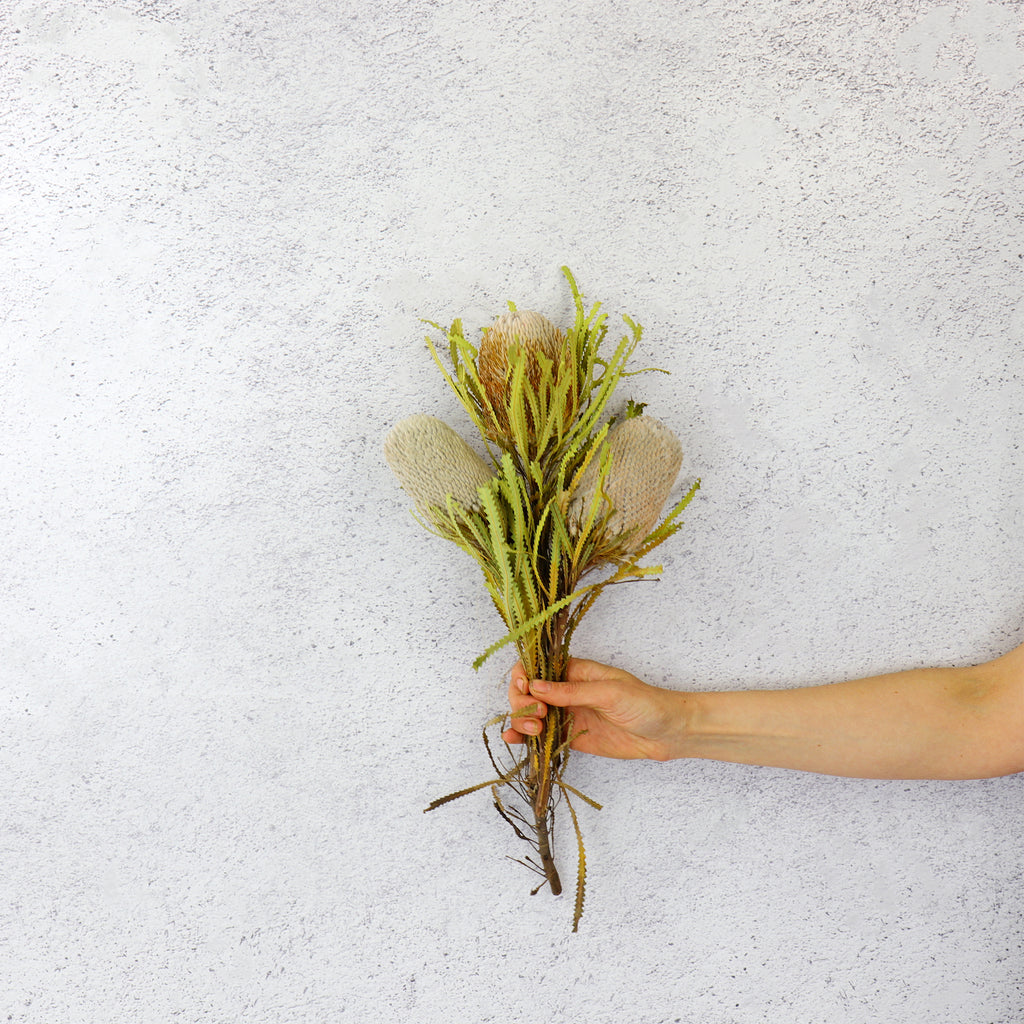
[384,413,494,514]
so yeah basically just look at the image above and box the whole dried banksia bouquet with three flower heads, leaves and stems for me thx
[385,267,699,931]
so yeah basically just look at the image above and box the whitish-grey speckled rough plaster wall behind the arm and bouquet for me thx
[0,0,1024,1024]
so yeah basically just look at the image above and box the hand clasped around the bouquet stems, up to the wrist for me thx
[503,657,687,761]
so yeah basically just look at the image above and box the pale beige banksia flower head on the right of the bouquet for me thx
[568,416,683,550]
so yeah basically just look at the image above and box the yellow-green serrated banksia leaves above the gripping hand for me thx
[419,267,699,678]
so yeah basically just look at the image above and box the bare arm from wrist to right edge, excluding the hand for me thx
[673,652,1024,779]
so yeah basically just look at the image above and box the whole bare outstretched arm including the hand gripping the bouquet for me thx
[506,646,1024,779]
